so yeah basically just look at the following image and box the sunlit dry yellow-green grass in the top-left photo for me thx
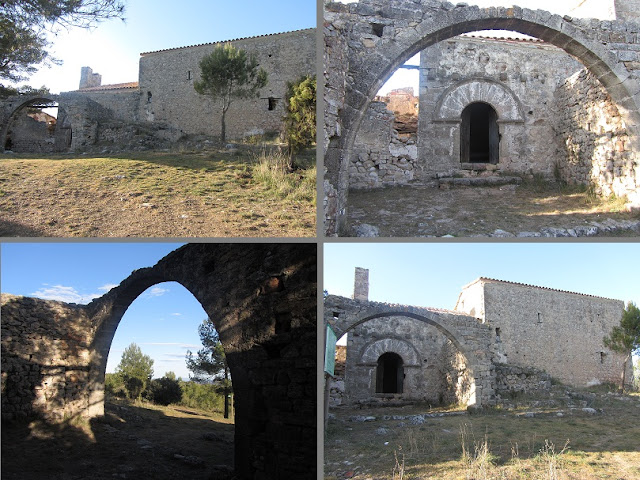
[0,147,316,237]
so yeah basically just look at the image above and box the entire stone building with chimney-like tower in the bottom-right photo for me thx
[325,269,632,405]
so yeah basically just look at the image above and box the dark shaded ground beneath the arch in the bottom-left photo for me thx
[2,401,234,480]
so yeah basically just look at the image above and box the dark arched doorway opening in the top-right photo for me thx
[460,102,500,165]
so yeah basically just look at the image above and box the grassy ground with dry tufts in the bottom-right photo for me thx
[325,394,640,480]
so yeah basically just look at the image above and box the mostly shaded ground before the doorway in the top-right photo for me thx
[348,179,638,237]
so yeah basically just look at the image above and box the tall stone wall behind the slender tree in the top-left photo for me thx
[138,29,316,139]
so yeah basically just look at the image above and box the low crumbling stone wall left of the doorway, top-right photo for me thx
[349,102,418,189]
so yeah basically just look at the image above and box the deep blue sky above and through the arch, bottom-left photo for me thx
[0,242,212,379]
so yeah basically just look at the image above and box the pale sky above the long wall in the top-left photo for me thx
[20,0,317,93]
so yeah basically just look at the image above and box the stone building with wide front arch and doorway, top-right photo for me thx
[324,0,640,235]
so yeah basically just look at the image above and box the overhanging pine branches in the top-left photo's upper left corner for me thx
[0,0,124,82]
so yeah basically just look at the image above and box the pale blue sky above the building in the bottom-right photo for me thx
[324,242,640,309]
